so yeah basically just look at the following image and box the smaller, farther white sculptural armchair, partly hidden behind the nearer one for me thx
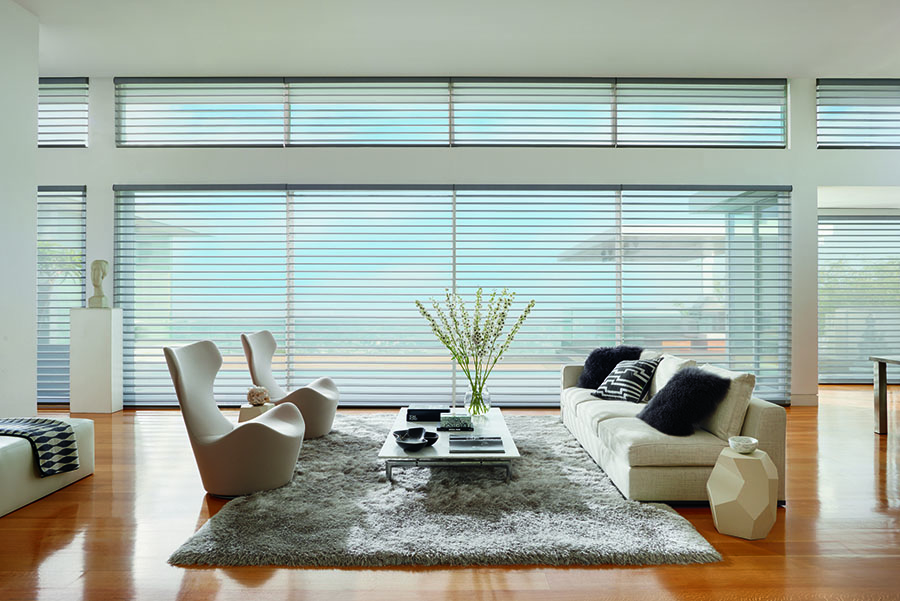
[241,330,341,438]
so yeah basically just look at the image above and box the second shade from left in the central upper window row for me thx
[288,80,450,146]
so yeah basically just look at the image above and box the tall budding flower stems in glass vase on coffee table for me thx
[416,288,534,415]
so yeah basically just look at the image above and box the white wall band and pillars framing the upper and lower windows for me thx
[39,73,900,404]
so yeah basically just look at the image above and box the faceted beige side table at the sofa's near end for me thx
[706,448,778,540]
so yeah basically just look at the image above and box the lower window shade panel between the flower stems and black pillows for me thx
[456,189,621,403]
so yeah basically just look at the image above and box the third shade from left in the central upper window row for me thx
[453,80,613,146]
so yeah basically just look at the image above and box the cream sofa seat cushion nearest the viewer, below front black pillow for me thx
[597,414,728,467]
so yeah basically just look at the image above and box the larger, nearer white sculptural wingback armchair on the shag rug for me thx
[163,340,304,497]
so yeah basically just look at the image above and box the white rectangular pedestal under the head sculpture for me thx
[69,308,122,413]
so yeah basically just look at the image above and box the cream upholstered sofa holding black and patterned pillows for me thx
[560,356,786,501]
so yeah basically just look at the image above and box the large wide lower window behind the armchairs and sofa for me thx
[115,186,790,405]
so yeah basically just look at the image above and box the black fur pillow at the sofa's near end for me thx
[637,367,731,436]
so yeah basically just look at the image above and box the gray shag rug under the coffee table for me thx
[169,415,721,567]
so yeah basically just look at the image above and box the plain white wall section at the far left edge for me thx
[0,0,38,417]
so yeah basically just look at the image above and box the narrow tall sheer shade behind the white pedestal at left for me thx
[37,186,85,403]
